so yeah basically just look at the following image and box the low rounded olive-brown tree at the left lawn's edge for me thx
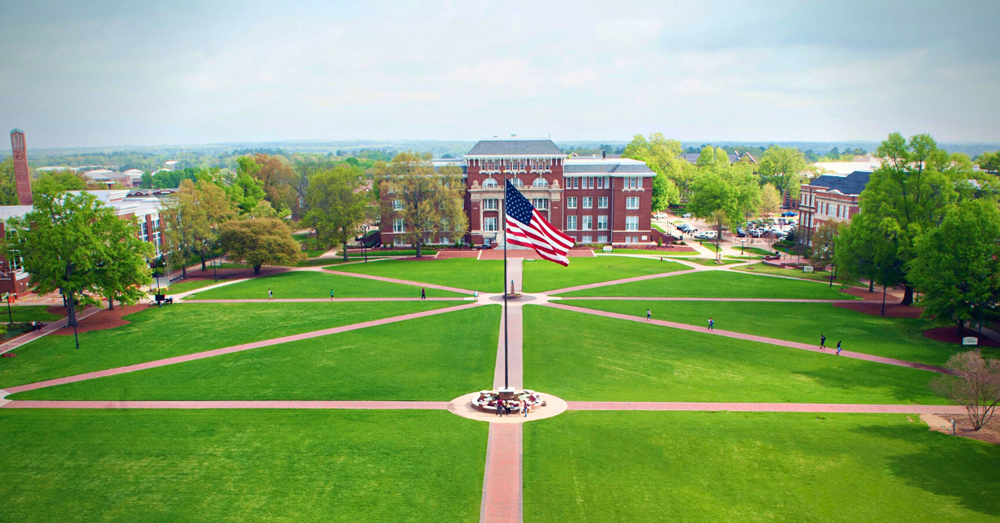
[219,218,304,274]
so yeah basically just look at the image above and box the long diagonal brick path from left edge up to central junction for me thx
[7,302,487,394]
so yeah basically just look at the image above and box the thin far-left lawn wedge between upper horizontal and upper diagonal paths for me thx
[189,271,464,300]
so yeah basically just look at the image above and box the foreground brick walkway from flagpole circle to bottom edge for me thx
[479,423,524,523]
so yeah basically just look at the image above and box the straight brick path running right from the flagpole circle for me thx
[567,401,966,415]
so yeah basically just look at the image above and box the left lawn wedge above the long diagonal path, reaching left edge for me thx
[0,301,454,388]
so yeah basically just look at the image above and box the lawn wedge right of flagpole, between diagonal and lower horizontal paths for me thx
[524,305,946,404]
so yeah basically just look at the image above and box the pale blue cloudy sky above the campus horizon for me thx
[0,0,1000,148]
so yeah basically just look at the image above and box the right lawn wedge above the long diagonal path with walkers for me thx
[560,300,968,365]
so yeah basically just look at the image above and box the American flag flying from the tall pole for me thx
[506,180,574,266]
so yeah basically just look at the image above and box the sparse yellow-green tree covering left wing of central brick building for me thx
[373,152,469,258]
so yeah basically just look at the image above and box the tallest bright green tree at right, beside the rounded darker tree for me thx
[852,133,971,305]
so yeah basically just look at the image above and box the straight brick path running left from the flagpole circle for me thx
[3,400,448,410]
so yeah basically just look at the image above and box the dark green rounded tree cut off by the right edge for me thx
[909,200,1000,336]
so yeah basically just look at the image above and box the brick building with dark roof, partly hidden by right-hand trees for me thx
[798,171,872,245]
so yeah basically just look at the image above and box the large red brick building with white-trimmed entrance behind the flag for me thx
[381,138,655,245]
